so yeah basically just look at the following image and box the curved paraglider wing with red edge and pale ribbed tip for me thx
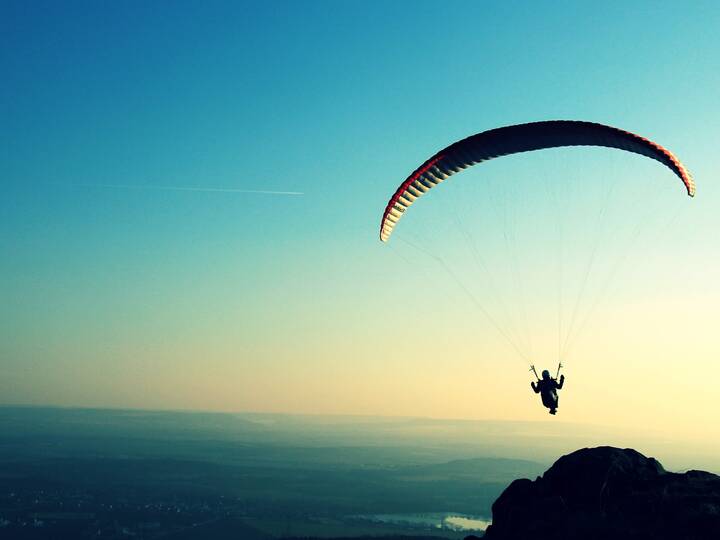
[380,120,695,242]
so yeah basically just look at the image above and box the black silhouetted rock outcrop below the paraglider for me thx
[478,446,720,540]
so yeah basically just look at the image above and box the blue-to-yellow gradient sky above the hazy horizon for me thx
[0,0,720,444]
